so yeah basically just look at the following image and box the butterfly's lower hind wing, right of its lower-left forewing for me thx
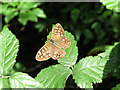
[52,45,66,60]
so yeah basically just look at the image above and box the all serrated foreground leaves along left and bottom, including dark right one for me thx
[0,26,120,88]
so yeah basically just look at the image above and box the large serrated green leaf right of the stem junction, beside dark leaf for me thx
[73,56,107,88]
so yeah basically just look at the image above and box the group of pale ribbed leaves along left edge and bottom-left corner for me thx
[0,26,43,89]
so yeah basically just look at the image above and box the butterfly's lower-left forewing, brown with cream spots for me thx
[35,41,52,61]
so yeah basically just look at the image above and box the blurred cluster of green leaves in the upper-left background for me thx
[0,2,47,26]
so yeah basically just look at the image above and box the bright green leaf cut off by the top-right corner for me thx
[100,0,120,12]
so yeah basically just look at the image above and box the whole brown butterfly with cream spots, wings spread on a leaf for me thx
[35,23,71,61]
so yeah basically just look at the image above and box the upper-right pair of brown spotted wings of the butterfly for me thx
[51,23,71,49]
